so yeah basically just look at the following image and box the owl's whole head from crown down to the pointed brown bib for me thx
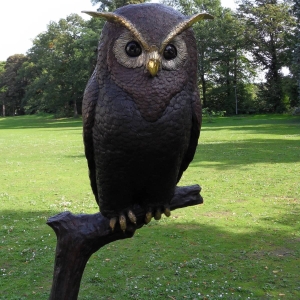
[86,3,212,122]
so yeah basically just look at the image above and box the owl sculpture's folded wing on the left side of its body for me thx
[82,72,99,203]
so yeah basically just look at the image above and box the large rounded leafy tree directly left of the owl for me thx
[22,14,102,117]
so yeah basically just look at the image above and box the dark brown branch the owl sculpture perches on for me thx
[47,185,203,300]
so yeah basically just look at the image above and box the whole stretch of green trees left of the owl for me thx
[0,14,103,116]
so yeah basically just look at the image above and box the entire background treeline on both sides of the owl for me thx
[0,0,300,117]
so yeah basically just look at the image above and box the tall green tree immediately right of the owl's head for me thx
[164,0,255,113]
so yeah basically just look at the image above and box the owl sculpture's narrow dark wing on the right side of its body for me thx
[177,93,202,183]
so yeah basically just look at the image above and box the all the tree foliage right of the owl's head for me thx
[163,0,295,114]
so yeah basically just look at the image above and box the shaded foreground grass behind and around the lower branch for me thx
[0,206,300,300]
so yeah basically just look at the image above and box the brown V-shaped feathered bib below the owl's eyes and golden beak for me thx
[108,54,189,123]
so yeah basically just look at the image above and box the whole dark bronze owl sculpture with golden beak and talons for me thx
[83,3,212,231]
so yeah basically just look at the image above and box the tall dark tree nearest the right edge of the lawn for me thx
[238,0,295,112]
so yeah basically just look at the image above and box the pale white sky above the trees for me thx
[0,0,236,61]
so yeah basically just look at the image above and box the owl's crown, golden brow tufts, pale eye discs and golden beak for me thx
[84,3,213,77]
